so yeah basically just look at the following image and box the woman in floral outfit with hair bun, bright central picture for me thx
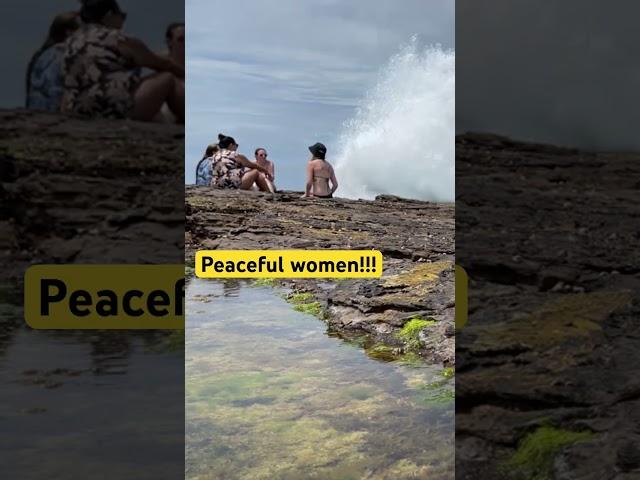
[211,134,272,192]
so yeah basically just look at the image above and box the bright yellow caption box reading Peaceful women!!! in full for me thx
[195,250,382,278]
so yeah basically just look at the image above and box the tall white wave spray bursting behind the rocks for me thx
[335,38,455,202]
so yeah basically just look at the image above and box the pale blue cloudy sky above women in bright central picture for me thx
[185,0,455,190]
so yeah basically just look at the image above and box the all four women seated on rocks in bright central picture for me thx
[196,134,338,198]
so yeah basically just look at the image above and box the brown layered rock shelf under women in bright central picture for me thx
[185,186,455,365]
